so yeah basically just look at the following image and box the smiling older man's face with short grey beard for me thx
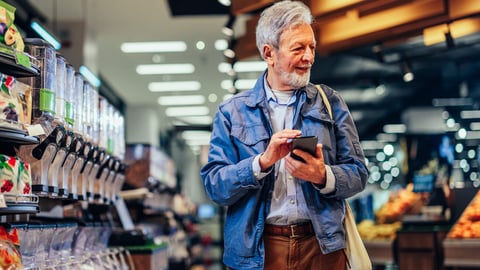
[266,24,316,90]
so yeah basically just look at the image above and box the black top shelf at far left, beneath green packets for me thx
[0,46,40,78]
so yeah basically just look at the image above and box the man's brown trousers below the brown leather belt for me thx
[263,234,347,270]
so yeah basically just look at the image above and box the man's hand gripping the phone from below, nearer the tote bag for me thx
[285,144,327,186]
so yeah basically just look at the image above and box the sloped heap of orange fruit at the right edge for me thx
[447,192,480,239]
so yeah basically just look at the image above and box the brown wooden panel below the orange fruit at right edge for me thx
[443,238,480,267]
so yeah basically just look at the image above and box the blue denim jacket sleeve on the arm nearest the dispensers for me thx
[200,106,263,206]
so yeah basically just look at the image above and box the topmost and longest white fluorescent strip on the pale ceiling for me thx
[120,41,187,53]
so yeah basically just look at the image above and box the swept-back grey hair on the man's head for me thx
[256,1,313,59]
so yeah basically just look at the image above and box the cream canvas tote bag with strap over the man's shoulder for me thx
[317,85,372,270]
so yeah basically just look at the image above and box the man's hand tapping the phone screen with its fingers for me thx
[259,129,302,171]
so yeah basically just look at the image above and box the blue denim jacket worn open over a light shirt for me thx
[201,72,368,270]
